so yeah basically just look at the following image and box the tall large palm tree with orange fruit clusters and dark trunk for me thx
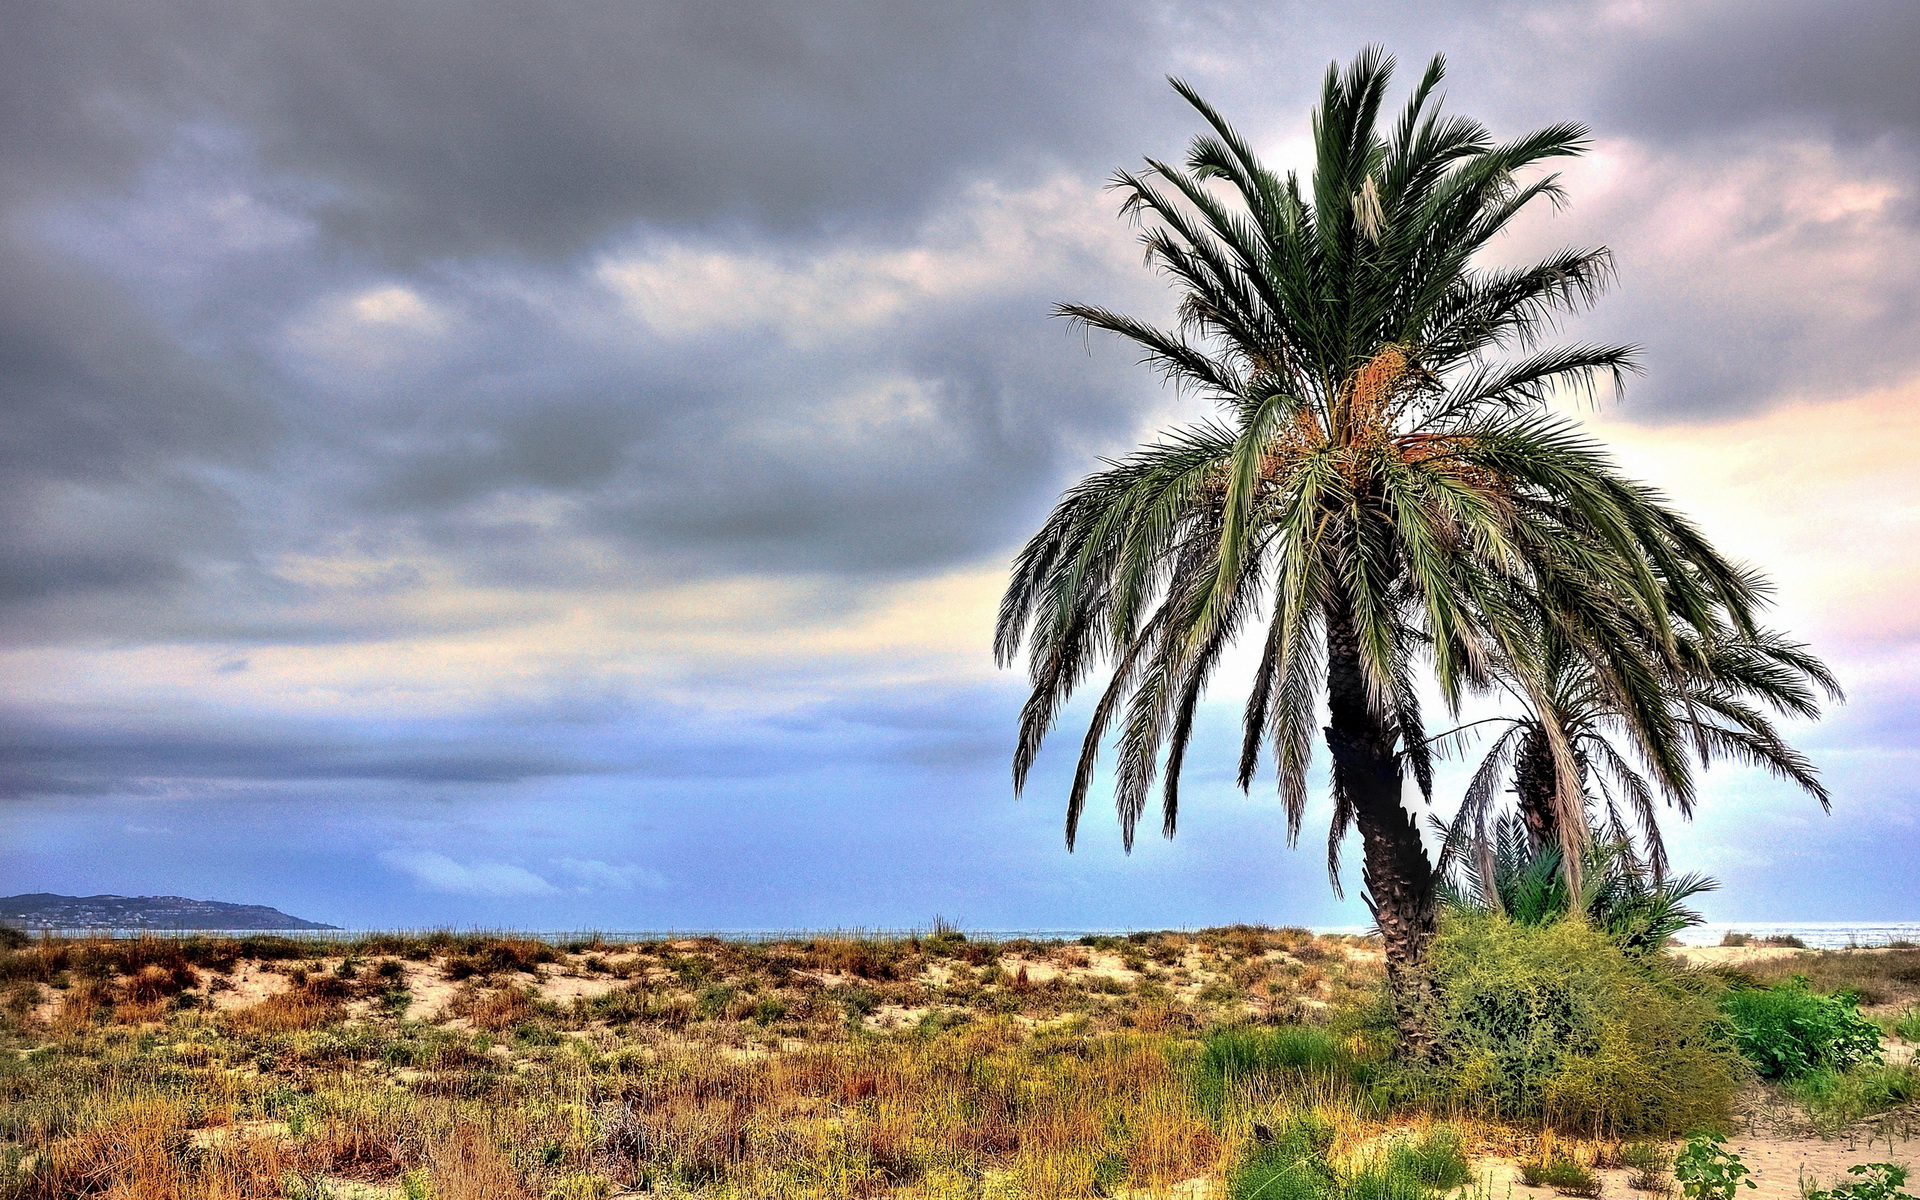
[995,50,1757,981]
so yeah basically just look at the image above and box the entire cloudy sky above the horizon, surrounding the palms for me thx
[0,0,1920,929]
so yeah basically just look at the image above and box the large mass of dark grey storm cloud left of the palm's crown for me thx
[0,4,1213,636]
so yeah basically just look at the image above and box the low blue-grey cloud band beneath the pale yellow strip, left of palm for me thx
[0,687,1004,801]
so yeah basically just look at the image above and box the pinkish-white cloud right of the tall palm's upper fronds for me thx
[1503,134,1920,422]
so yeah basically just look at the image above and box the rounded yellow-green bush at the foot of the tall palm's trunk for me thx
[1417,912,1738,1137]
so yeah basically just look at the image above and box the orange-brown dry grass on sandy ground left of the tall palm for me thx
[0,927,1379,1200]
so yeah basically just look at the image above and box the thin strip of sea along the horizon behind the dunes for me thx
[22,922,1920,950]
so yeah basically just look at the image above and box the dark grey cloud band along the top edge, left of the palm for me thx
[4,0,1154,261]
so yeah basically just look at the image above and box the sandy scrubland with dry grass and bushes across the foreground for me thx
[0,924,1920,1200]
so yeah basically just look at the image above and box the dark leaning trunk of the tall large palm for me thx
[1327,603,1434,1056]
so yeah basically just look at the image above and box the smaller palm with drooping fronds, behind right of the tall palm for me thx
[1428,622,1843,879]
